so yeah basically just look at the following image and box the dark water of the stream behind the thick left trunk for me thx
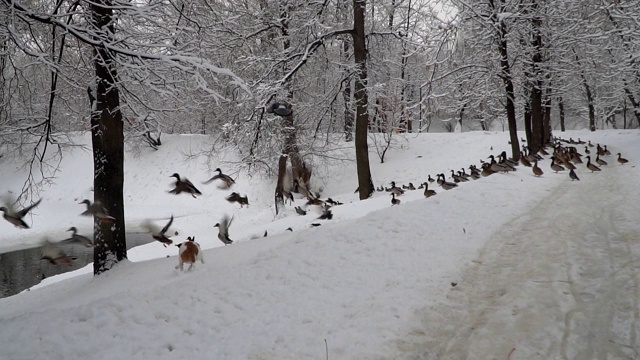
[0,233,154,298]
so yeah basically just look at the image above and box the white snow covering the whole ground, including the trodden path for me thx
[0,130,640,359]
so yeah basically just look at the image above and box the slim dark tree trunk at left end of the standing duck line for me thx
[352,0,374,200]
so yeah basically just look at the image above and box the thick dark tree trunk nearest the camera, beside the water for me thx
[89,0,127,275]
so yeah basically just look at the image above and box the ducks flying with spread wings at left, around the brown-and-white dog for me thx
[0,168,249,265]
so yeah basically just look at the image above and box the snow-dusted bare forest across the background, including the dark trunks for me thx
[0,0,640,273]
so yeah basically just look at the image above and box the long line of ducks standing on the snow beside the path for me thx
[376,137,629,206]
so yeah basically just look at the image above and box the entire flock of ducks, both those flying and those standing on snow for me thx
[0,138,628,265]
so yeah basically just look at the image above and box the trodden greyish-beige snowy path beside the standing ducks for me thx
[400,162,640,359]
